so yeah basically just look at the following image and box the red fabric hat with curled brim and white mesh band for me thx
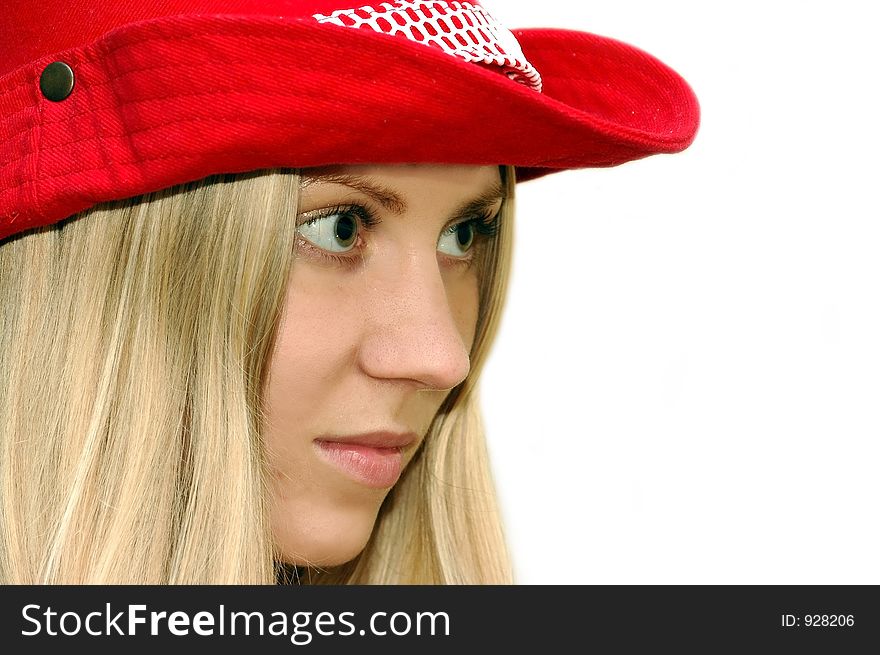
[0,0,699,239]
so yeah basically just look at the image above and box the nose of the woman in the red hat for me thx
[359,253,476,390]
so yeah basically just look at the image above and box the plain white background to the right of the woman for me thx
[482,0,880,584]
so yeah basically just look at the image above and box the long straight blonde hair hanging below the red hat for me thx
[0,167,515,584]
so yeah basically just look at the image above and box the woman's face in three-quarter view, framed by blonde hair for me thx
[266,164,502,566]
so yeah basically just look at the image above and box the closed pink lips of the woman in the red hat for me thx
[314,432,416,489]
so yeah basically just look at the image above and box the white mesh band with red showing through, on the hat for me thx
[313,0,541,93]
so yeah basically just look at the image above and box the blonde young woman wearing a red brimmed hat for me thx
[0,0,698,583]
